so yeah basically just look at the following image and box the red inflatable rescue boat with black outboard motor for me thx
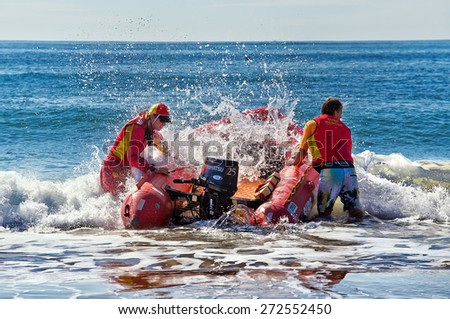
[121,107,319,229]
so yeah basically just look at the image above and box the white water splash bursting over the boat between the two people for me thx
[163,99,300,179]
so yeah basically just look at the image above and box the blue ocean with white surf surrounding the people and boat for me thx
[0,41,450,299]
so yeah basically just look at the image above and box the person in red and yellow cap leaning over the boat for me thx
[100,103,170,195]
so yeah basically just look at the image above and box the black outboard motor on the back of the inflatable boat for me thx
[199,157,239,219]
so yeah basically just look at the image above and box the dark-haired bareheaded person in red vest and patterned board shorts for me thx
[292,97,364,217]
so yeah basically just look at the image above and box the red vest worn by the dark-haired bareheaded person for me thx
[307,114,353,167]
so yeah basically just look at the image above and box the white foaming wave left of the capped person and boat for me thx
[0,171,120,229]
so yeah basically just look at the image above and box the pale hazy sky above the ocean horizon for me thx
[0,0,450,41]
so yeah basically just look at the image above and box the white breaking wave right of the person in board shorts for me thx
[355,152,450,220]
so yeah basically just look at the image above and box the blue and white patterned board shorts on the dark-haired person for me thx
[317,167,361,214]
